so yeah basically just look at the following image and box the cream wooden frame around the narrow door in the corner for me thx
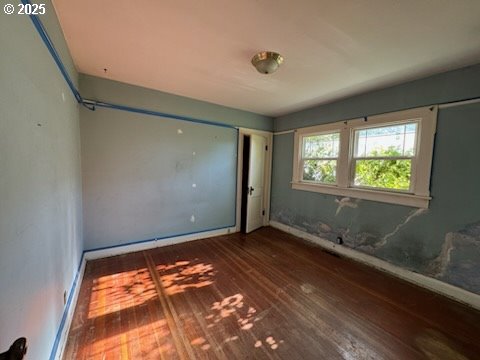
[235,128,273,232]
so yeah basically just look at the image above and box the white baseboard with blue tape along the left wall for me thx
[50,255,87,360]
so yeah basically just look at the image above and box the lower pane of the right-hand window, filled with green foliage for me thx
[354,159,412,190]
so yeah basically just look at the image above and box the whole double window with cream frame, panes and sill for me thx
[292,107,437,208]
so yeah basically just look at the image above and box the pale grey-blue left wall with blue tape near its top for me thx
[0,1,83,359]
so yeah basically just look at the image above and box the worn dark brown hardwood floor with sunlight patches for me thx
[64,228,480,359]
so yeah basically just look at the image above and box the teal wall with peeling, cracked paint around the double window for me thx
[271,65,480,294]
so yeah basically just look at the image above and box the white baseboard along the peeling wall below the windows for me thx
[270,220,480,310]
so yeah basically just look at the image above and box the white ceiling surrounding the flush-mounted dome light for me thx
[54,0,480,116]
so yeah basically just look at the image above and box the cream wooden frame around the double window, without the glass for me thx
[291,106,438,208]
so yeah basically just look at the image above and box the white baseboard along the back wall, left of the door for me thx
[84,227,237,260]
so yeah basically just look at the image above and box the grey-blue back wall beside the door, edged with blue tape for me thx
[80,75,273,250]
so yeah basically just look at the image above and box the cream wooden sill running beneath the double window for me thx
[291,181,431,209]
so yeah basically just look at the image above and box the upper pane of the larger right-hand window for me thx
[354,123,417,157]
